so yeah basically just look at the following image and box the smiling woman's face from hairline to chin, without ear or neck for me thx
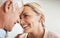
[20,6,40,32]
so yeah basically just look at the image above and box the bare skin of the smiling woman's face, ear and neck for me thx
[20,6,44,38]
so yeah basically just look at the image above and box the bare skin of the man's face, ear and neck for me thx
[0,0,23,31]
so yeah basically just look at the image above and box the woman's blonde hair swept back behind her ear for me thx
[24,2,45,27]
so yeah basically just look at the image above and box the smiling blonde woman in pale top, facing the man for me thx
[16,3,57,38]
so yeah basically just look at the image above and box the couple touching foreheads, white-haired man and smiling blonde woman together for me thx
[0,0,59,38]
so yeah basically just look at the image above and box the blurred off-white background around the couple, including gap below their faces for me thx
[7,0,60,38]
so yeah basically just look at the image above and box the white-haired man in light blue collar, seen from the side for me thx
[0,0,23,38]
